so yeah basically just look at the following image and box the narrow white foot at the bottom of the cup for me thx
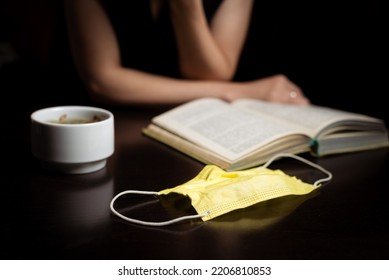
[41,159,107,174]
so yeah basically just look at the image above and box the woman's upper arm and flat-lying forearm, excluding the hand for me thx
[65,0,223,104]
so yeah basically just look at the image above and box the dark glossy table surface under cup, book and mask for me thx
[0,105,389,260]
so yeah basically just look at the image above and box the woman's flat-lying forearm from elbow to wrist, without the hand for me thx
[84,67,231,105]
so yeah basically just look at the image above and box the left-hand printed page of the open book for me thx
[153,98,301,160]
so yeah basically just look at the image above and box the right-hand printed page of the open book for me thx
[230,99,380,138]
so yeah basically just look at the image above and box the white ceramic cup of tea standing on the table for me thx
[31,106,114,174]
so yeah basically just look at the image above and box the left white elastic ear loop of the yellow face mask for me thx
[110,190,209,226]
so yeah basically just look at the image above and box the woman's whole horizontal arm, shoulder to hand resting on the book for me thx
[64,0,306,105]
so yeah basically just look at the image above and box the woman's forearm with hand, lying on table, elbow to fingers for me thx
[86,65,309,105]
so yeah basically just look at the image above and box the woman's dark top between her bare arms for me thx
[98,0,221,77]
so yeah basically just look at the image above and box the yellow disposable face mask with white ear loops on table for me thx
[110,154,332,226]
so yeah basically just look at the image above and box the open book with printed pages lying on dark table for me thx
[143,98,389,170]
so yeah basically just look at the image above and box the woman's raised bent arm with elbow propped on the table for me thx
[169,0,253,81]
